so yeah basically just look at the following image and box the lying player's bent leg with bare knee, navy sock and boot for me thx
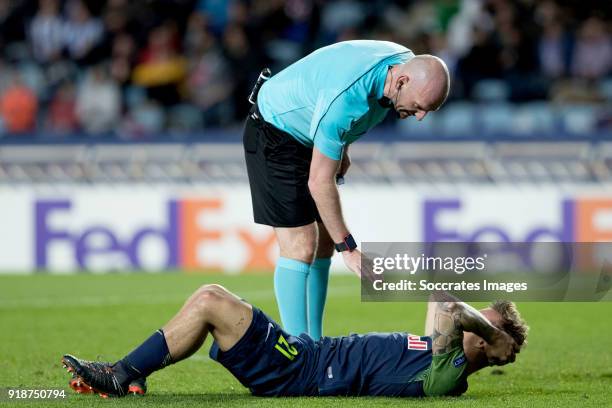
[62,285,253,396]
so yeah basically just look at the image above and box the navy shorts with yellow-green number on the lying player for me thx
[210,307,318,396]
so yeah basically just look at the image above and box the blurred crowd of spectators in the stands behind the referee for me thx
[0,0,612,140]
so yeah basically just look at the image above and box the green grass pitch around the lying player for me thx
[0,273,612,408]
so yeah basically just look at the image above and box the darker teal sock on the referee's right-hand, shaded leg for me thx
[308,258,331,340]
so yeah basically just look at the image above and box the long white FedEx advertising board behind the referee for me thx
[0,185,612,273]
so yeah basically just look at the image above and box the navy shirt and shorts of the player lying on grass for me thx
[210,307,467,397]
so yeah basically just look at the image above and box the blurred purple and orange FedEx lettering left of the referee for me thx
[34,198,275,270]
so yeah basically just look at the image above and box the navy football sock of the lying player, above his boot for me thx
[119,329,172,380]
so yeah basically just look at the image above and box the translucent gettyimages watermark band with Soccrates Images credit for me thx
[361,242,612,302]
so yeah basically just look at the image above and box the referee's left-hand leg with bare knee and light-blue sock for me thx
[274,222,317,336]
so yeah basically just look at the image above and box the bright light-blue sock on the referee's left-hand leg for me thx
[274,257,310,336]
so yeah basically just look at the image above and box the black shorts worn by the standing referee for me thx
[243,106,321,227]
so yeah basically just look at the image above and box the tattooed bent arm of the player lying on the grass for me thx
[431,302,499,354]
